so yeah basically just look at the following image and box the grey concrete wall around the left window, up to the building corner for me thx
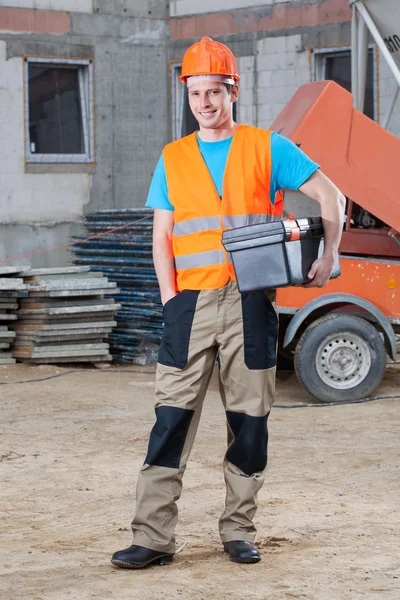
[0,0,169,265]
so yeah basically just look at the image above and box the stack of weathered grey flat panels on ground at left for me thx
[12,266,121,363]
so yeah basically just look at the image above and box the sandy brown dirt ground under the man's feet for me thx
[0,365,400,600]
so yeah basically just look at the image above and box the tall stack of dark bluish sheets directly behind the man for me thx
[73,209,162,362]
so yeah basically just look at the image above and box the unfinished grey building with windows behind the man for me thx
[0,0,400,267]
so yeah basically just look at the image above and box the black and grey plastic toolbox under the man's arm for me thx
[222,216,340,292]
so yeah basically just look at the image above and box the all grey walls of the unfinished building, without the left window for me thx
[0,0,400,265]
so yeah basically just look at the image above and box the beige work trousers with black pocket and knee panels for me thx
[132,281,278,553]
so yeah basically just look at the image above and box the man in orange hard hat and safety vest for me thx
[112,38,345,568]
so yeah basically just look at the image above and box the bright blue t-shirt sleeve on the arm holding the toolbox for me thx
[270,131,319,203]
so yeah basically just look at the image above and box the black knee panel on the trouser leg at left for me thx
[144,406,194,469]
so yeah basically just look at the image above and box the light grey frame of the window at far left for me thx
[23,56,94,164]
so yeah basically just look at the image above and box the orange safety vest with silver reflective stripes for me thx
[163,125,282,291]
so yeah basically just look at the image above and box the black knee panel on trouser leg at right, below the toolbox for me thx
[226,411,269,476]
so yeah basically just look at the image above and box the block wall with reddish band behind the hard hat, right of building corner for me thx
[170,0,400,214]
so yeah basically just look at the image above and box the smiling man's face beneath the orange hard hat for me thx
[188,80,239,129]
